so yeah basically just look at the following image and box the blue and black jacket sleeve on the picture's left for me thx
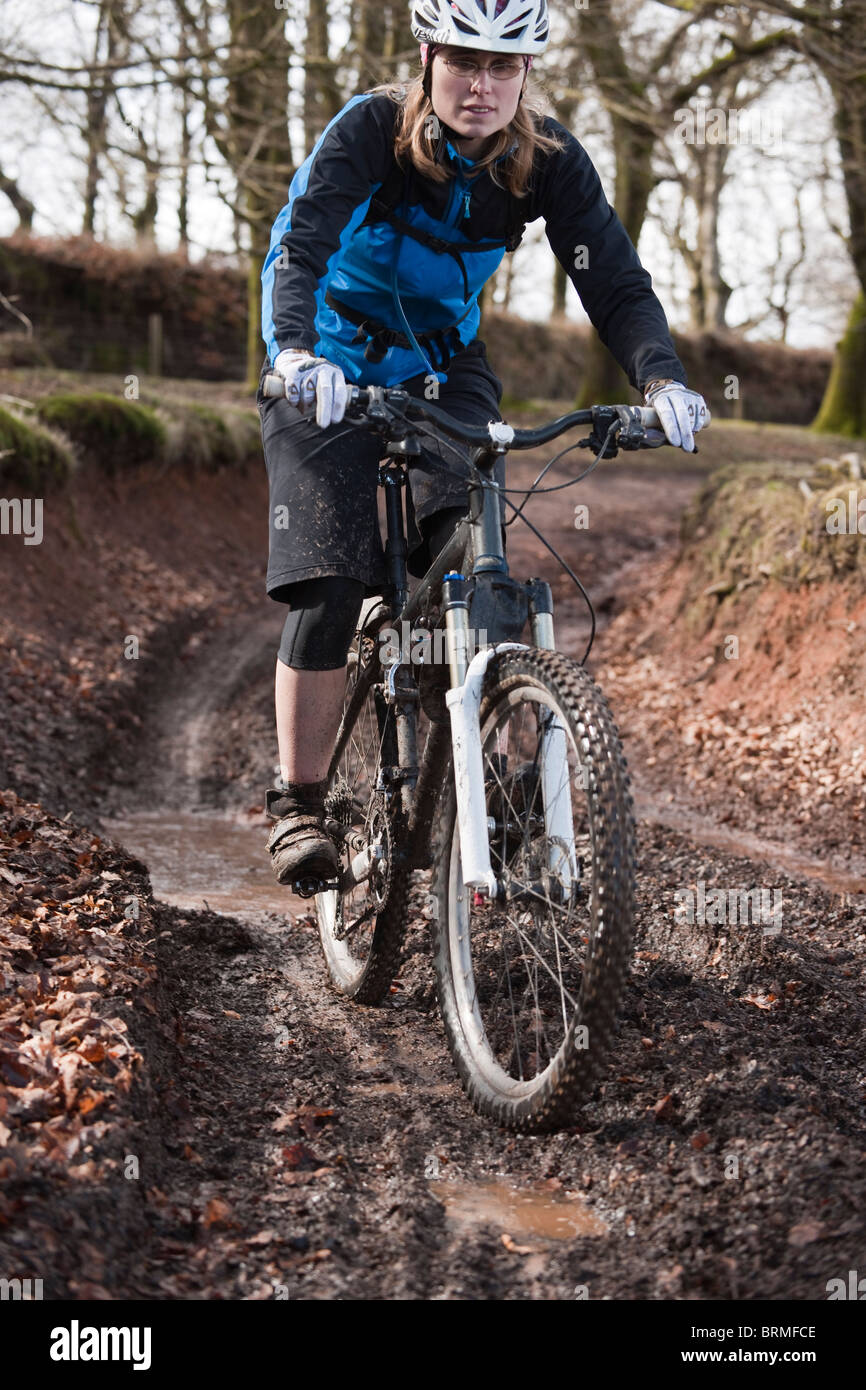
[261,93,396,361]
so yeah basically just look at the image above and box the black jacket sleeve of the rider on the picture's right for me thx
[537,117,685,391]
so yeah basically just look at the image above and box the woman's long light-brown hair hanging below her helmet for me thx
[370,56,563,197]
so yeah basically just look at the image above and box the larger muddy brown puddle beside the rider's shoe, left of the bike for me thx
[103,810,296,920]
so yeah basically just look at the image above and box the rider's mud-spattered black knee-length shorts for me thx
[256,338,505,603]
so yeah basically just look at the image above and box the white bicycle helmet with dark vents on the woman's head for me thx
[411,0,550,54]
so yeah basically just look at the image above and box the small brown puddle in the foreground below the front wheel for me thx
[431,1179,607,1240]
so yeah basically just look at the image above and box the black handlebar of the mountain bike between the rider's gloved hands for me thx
[261,373,667,449]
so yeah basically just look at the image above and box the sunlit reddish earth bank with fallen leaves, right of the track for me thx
[598,456,866,872]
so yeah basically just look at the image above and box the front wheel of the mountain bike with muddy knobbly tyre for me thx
[432,648,635,1133]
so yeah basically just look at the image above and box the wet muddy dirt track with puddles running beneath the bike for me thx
[0,414,866,1300]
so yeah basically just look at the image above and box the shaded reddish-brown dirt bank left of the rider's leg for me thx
[0,439,273,817]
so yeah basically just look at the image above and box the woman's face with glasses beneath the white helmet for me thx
[431,46,525,160]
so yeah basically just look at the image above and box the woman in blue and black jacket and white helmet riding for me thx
[259,0,709,883]
